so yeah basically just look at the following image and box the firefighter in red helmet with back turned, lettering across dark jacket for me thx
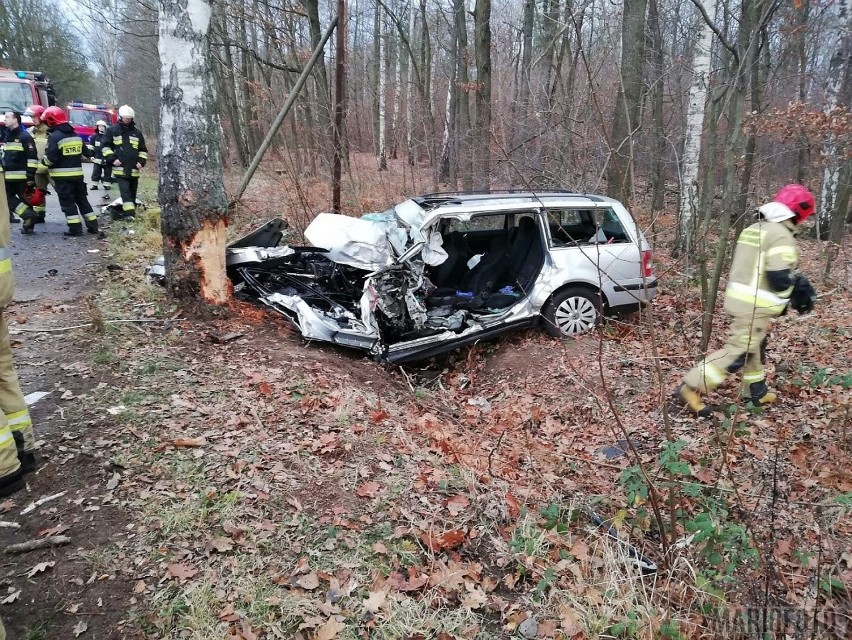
[41,107,98,236]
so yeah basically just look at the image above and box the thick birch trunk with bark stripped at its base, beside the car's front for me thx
[159,0,231,306]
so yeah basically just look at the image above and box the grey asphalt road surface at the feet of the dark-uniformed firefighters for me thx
[12,164,110,303]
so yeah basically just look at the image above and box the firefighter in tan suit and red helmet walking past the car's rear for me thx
[676,184,816,417]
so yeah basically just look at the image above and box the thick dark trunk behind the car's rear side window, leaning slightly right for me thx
[607,0,648,206]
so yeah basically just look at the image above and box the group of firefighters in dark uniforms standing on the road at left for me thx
[2,105,148,237]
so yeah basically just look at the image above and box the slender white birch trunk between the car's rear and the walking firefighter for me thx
[678,0,718,253]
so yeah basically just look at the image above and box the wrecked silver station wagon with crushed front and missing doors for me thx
[227,191,657,363]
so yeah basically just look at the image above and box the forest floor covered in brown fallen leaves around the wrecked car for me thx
[0,156,852,640]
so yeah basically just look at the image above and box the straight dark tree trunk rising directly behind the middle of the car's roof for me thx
[473,0,491,189]
